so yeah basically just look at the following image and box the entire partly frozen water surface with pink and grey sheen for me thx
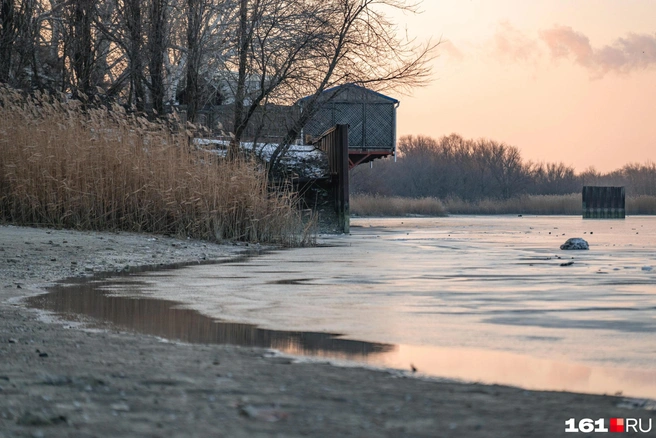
[28,216,656,398]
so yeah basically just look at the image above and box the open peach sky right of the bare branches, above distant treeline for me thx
[390,0,656,172]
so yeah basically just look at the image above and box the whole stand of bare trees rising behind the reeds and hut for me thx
[0,0,435,163]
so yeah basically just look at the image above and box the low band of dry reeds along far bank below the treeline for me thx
[351,193,656,216]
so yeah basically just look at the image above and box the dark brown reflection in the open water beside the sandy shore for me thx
[27,281,395,360]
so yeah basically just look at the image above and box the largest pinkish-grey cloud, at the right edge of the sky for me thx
[540,26,656,76]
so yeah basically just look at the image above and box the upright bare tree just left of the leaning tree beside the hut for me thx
[225,0,329,156]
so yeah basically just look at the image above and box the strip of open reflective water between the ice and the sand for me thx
[27,274,656,398]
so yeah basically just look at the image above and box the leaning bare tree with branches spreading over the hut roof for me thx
[269,0,439,169]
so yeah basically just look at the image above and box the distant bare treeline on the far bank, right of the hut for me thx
[351,134,656,201]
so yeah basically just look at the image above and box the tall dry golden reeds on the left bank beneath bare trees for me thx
[0,88,314,245]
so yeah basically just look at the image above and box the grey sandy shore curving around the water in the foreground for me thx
[0,226,656,438]
